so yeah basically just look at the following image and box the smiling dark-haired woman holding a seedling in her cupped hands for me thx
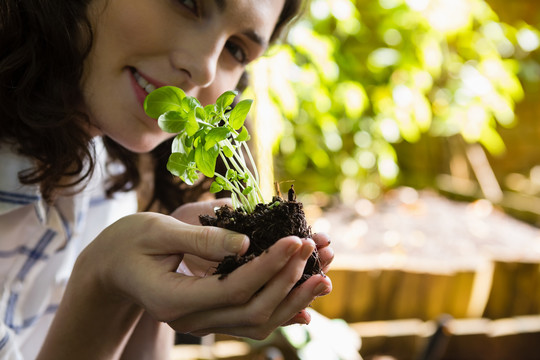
[0,0,333,359]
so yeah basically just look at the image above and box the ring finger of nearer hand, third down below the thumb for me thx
[191,275,332,340]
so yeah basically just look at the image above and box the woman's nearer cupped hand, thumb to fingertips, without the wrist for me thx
[85,213,331,339]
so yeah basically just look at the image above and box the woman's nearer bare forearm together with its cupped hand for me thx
[38,213,331,360]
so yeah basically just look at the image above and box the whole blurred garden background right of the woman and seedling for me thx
[175,0,540,359]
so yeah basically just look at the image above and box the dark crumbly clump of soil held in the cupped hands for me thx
[199,196,322,286]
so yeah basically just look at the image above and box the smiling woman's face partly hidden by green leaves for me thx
[82,0,285,152]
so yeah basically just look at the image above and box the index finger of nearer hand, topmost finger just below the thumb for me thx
[156,236,302,321]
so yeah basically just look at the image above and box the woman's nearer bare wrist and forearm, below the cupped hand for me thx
[38,243,143,360]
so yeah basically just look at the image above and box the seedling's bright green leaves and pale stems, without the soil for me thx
[144,86,264,213]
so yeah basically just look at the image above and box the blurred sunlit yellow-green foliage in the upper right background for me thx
[254,0,540,199]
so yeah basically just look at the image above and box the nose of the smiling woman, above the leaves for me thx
[171,37,224,87]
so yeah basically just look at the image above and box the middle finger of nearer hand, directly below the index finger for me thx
[171,239,315,330]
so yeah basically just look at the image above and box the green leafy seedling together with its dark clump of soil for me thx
[144,86,322,285]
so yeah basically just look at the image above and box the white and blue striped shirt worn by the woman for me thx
[0,138,137,360]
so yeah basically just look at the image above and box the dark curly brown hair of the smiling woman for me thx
[0,0,302,211]
